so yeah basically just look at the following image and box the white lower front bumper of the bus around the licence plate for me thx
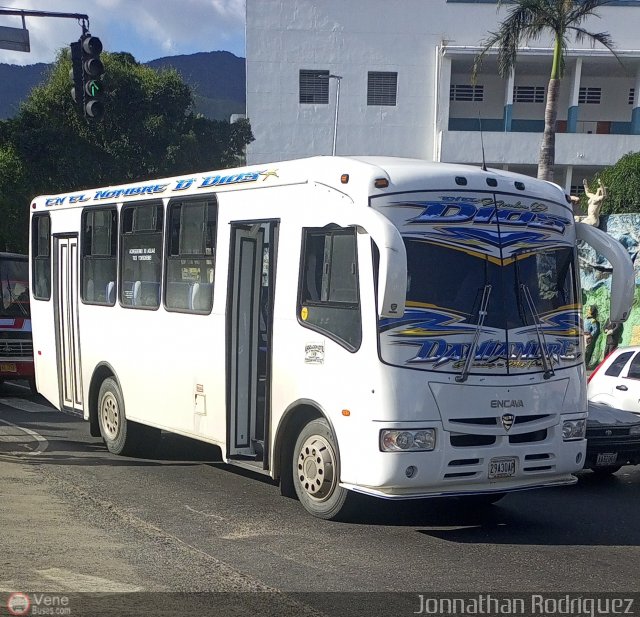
[341,417,587,499]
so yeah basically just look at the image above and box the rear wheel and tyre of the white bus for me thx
[98,377,137,456]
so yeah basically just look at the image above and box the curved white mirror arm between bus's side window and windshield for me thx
[354,208,407,317]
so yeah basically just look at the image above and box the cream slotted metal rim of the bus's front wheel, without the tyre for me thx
[298,435,336,501]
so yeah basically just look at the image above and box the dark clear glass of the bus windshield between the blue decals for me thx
[405,238,576,330]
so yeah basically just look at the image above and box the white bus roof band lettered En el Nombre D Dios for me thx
[32,156,564,210]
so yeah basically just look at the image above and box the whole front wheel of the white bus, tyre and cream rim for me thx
[292,418,352,520]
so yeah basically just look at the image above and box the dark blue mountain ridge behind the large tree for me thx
[0,51,245,120]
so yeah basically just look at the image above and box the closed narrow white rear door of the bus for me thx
[53,236,83,414]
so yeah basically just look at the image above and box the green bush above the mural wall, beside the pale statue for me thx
[580,152,640,214]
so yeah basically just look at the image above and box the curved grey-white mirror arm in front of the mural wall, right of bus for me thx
[575,223,636,322]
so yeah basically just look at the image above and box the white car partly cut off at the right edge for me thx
[587,346,640,415]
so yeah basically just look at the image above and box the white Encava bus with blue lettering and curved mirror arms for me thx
[31,157,634,518]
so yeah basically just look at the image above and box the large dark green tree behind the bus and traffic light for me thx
[0,49,253,250]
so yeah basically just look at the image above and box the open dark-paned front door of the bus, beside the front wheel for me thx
[227,221,277,469]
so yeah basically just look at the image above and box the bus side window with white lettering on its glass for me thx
[120,203,163,309]
